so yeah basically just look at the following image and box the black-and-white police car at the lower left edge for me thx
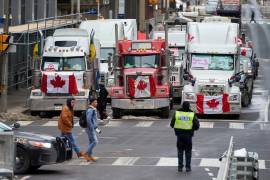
[0,122,72,174]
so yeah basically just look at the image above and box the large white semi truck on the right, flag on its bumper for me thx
[182,22,241,116]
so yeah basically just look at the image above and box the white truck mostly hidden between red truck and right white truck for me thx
[150,25,186,101]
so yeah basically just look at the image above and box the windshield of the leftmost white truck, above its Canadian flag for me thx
[41,57,86,71]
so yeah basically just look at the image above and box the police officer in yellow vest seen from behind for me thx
[170,101,200,172]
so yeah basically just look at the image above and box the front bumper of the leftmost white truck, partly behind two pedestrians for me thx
[30,98,88,111]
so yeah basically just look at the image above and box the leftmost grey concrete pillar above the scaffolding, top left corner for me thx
[11,0,21,26]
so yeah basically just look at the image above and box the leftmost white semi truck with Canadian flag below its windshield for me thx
[29,28,100,115]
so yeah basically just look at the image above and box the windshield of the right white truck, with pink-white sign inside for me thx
[191,54,234,71]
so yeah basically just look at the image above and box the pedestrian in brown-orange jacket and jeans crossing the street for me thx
[58,98,85,158]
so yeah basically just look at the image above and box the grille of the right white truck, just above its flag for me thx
[198,85,225,96]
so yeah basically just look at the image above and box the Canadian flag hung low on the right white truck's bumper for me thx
[196,93,230,114]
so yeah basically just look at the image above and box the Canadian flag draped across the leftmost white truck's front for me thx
[41,74,78,94]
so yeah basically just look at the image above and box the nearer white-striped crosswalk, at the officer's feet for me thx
[59,157,270,169]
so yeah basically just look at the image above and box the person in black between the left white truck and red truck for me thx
[97,83,109,120]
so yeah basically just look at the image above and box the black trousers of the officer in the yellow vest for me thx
[176,135,192,168]
